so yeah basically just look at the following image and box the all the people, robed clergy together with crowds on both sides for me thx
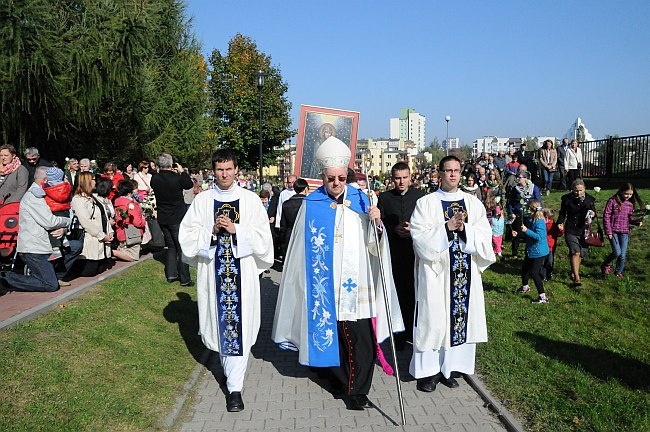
[0,137,642,412]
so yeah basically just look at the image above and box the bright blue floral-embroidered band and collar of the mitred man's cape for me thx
[304,185,369,367]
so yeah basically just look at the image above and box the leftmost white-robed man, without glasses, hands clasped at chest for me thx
[178,149,273,412]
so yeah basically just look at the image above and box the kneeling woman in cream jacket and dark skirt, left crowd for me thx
[71,172,113,277]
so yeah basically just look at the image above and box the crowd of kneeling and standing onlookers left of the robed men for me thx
[0,148,219,295]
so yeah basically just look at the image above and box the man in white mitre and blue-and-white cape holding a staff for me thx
[272,137,404,410]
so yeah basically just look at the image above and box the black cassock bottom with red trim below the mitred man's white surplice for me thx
[330,319,376,395]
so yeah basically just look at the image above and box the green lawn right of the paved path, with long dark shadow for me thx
[477,188,650,432]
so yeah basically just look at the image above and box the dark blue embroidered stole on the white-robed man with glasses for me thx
[442,199,472,346]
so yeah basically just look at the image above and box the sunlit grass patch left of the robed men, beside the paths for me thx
[0,260,203,431]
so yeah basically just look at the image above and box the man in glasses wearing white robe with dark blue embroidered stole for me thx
[409,156,495,392]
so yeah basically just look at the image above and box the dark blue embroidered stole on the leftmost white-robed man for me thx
[214,200,242,356]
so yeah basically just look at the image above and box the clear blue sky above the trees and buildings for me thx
[187,0,650,144]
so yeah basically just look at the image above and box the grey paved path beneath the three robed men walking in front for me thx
[172,270,512,432]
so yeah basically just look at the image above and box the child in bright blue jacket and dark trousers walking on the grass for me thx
[512,200,549,303]
